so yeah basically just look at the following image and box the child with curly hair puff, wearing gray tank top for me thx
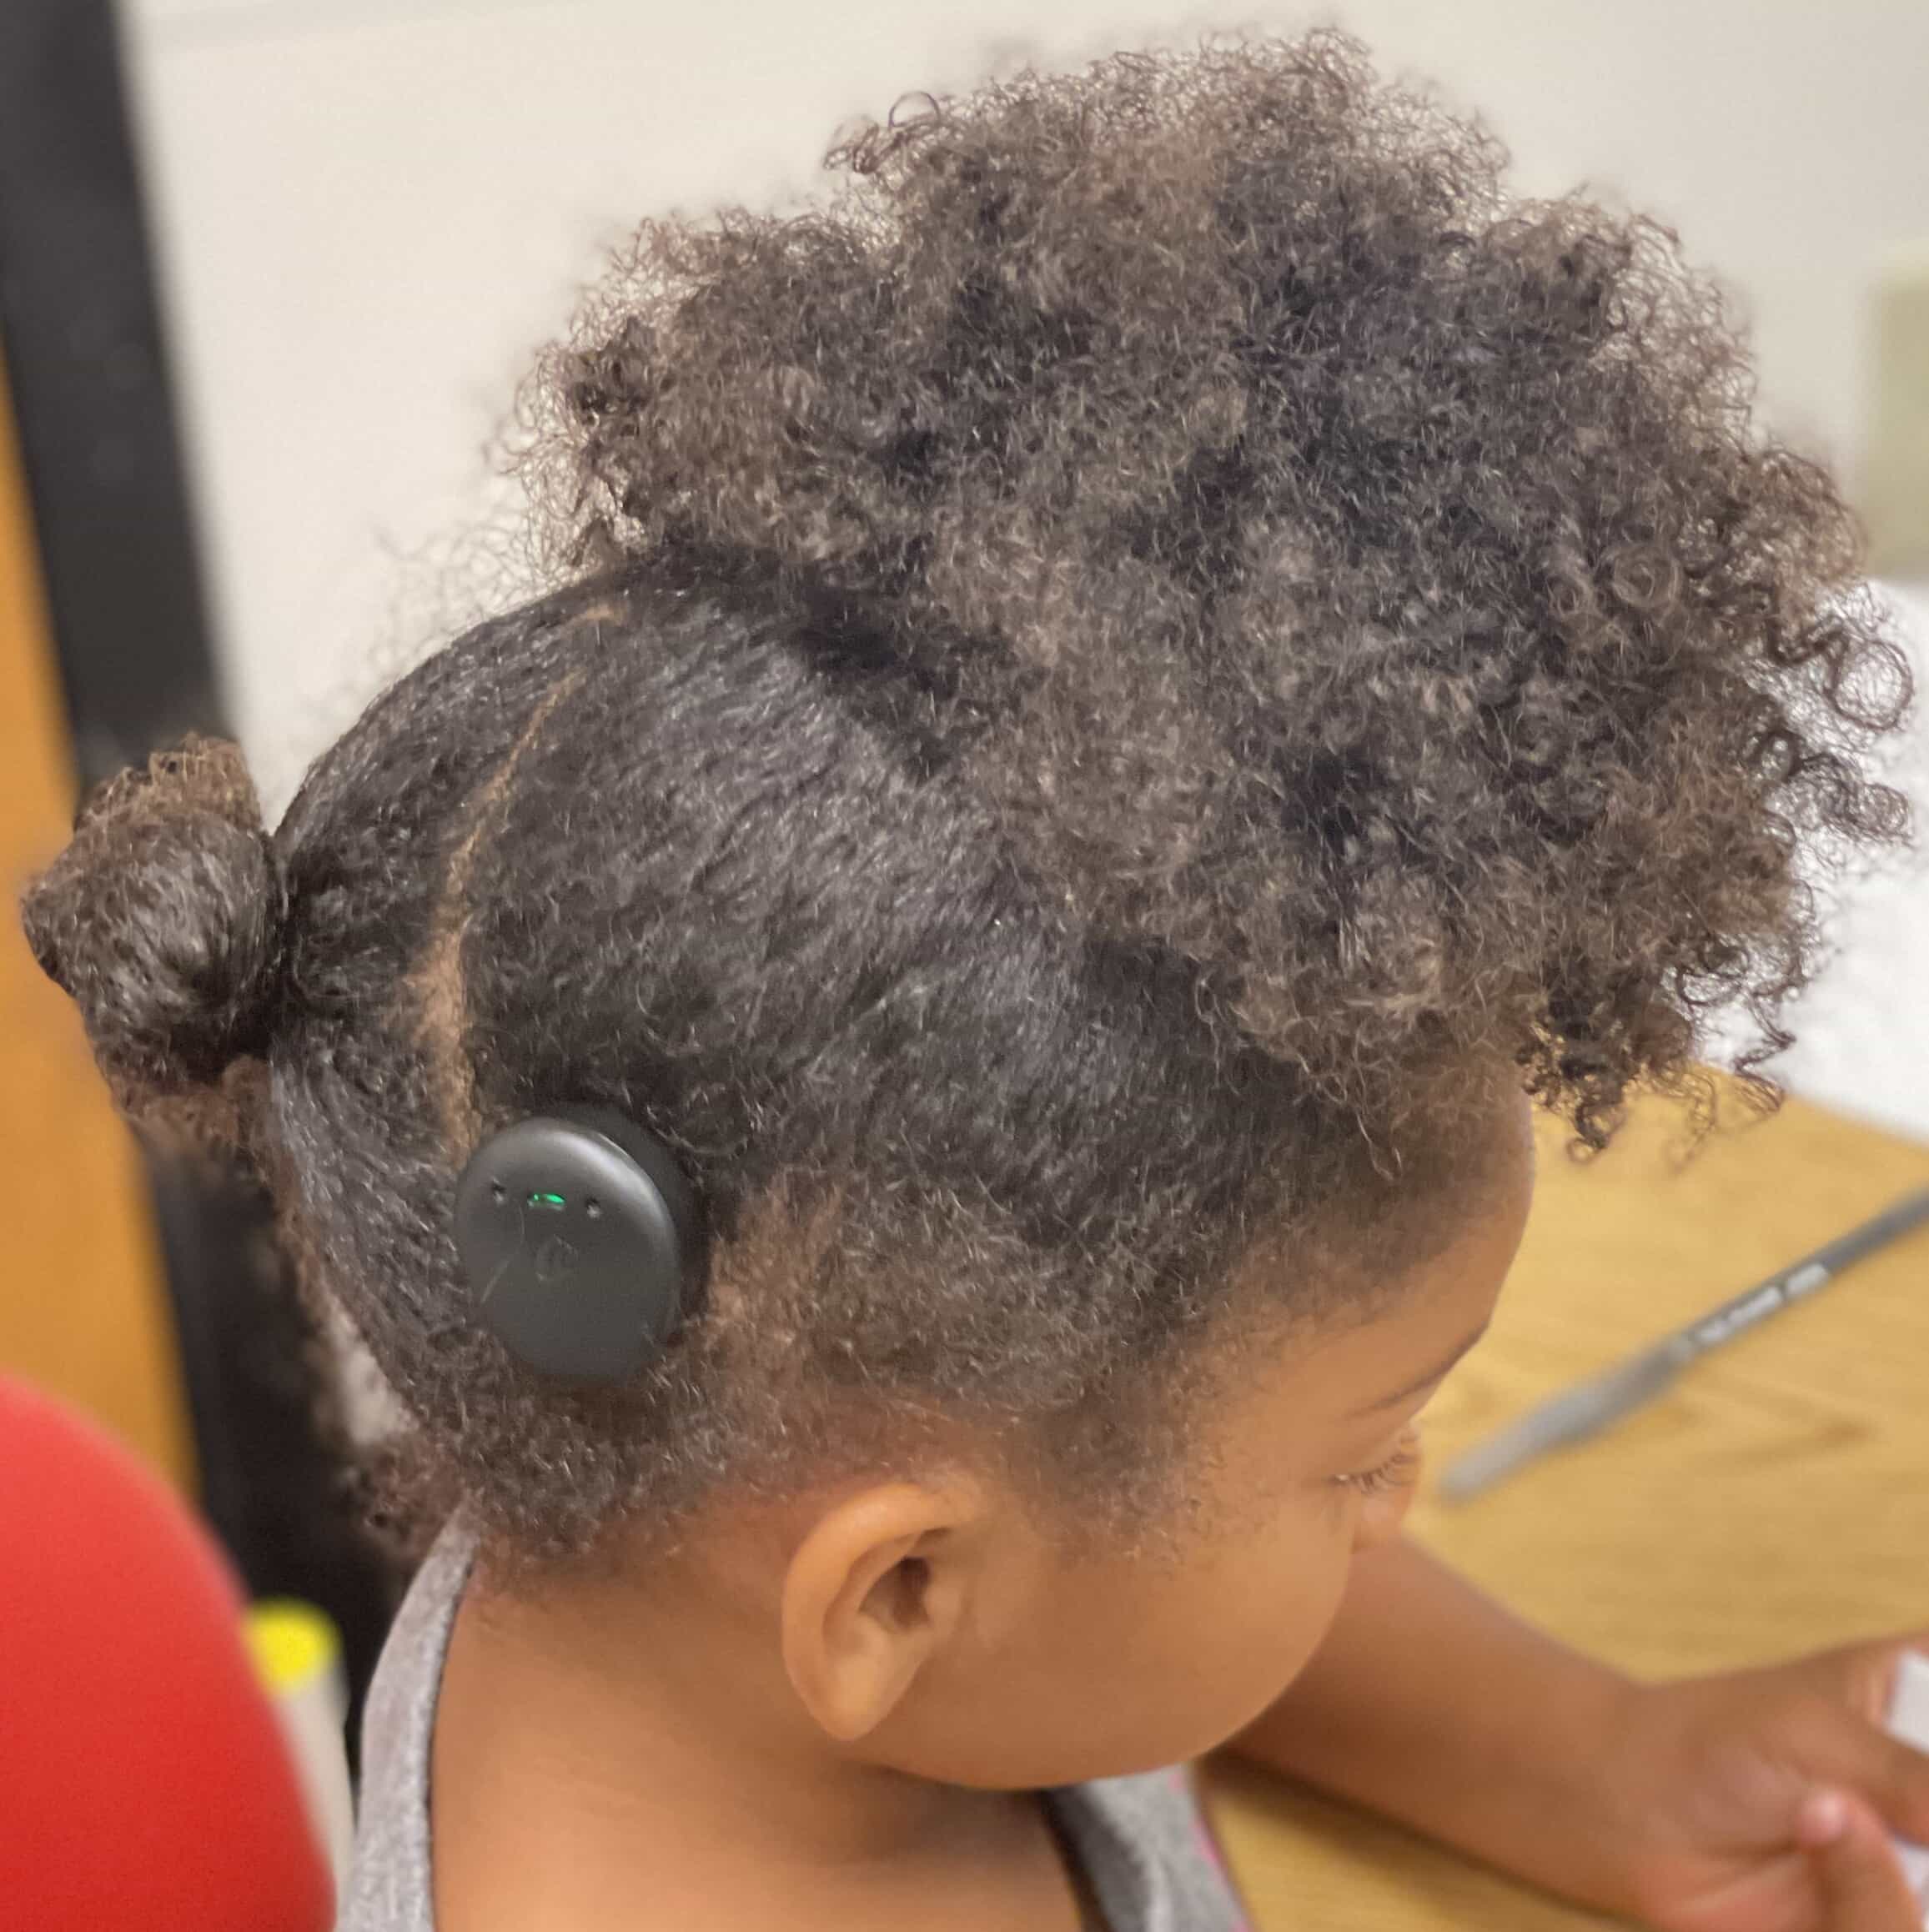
[27,37,1929,1932]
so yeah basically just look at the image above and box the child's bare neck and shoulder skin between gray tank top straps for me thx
[431,1553,1094,1932]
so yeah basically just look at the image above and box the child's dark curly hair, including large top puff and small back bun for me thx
[27,33,1910,1553]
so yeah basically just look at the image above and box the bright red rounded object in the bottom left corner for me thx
[0,1379,333,1932]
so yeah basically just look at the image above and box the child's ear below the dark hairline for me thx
[783,1482,982,1743]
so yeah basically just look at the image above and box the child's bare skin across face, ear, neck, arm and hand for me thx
[431,1097,1929,1932]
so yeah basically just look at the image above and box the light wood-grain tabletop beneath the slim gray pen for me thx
[1210,1096,1929,1932]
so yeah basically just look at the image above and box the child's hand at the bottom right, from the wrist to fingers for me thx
[1599,1642,1929,1932]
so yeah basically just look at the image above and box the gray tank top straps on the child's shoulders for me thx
[336,1526,1247,1932]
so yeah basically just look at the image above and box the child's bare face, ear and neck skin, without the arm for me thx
[433,1119,1531,1932]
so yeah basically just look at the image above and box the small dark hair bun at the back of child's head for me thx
[21,738,288,1099]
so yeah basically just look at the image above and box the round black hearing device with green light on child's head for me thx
[456,1107,704,1382]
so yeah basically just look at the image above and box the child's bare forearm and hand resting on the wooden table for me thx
[1233,1540,1929,1932]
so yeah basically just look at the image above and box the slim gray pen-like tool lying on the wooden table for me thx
[1440,1188,1929,1503]
